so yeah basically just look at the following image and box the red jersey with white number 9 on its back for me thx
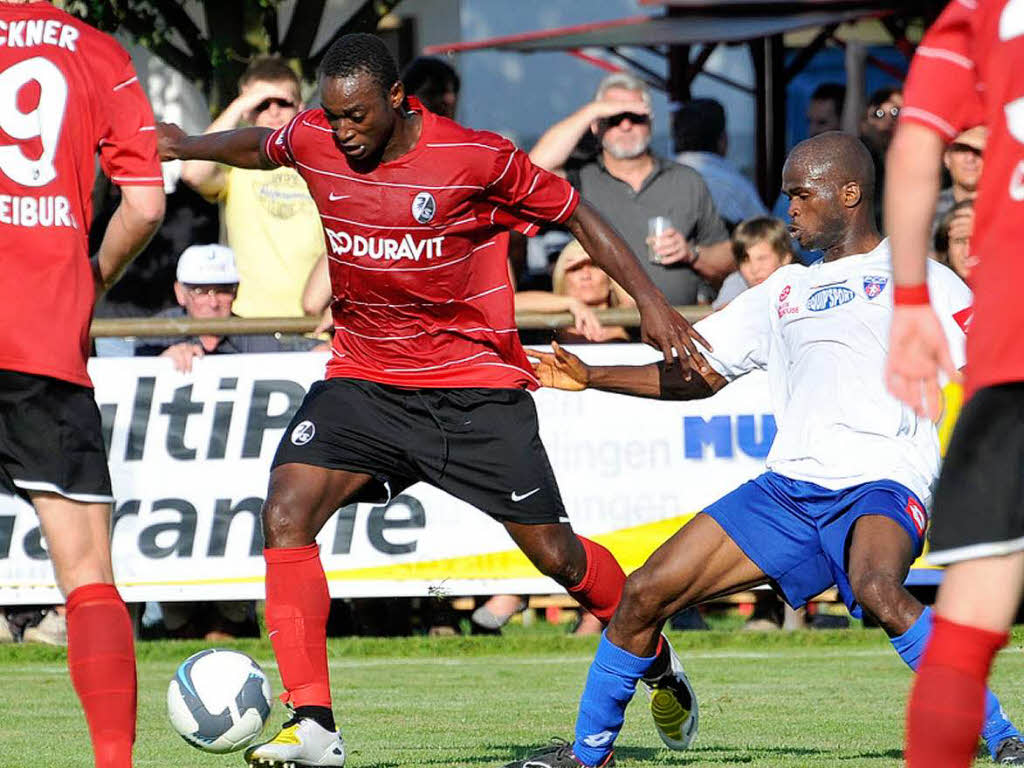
[0,2,162,386]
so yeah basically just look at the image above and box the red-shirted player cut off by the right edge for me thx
[886,0,1024,768]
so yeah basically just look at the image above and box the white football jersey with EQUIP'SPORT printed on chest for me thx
[696,239,972,504]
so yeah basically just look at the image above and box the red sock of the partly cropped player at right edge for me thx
[906,613,1009,768]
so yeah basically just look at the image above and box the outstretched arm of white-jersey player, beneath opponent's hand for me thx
[526,343,728,400]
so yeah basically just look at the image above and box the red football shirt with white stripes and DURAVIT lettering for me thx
[264,98,580,388]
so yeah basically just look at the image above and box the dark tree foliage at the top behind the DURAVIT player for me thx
[58,0,399,110]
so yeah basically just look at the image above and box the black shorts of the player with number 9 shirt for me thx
[0,371,114,503]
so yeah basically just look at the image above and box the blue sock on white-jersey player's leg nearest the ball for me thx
[572,632,655,765]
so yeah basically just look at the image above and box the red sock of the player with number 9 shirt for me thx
[68,584,135,768]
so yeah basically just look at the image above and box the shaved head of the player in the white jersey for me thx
[782,131,878,258]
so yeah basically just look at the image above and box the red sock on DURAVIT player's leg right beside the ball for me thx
[263,544,331,709]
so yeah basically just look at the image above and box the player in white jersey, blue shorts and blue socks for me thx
[499,132,1024,768]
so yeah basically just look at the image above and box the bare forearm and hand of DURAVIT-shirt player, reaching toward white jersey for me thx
[565,201,712,376]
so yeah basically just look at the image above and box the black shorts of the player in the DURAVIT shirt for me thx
[273,379,568,524]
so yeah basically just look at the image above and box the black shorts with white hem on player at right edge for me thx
[928,382,1024,565]
